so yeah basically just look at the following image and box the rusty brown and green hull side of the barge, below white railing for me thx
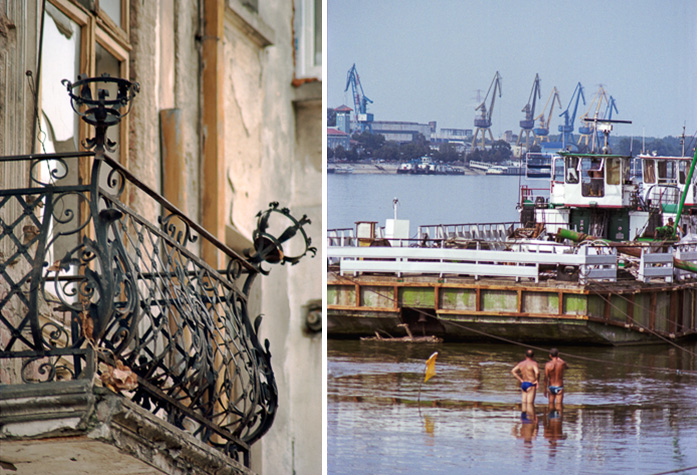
[327,272,697,345]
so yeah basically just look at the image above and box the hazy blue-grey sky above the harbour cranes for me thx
[326,0,697,137]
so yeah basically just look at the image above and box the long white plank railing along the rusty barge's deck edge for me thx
[327,247,617,283]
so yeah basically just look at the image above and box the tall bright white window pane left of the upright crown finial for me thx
[40,3,81,152]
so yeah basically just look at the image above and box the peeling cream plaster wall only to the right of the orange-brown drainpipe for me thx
[225,1,322,474]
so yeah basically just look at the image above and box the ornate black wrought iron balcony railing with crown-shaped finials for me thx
[0,79,315,465]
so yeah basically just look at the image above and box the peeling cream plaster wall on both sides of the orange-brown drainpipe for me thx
[129,0,322,474]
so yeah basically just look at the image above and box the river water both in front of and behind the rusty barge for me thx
[327,174,697,474]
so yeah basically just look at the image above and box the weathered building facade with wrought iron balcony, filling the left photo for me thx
[0,0,323,474]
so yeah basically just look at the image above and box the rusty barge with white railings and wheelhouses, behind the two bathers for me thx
[327,119,697,345]
